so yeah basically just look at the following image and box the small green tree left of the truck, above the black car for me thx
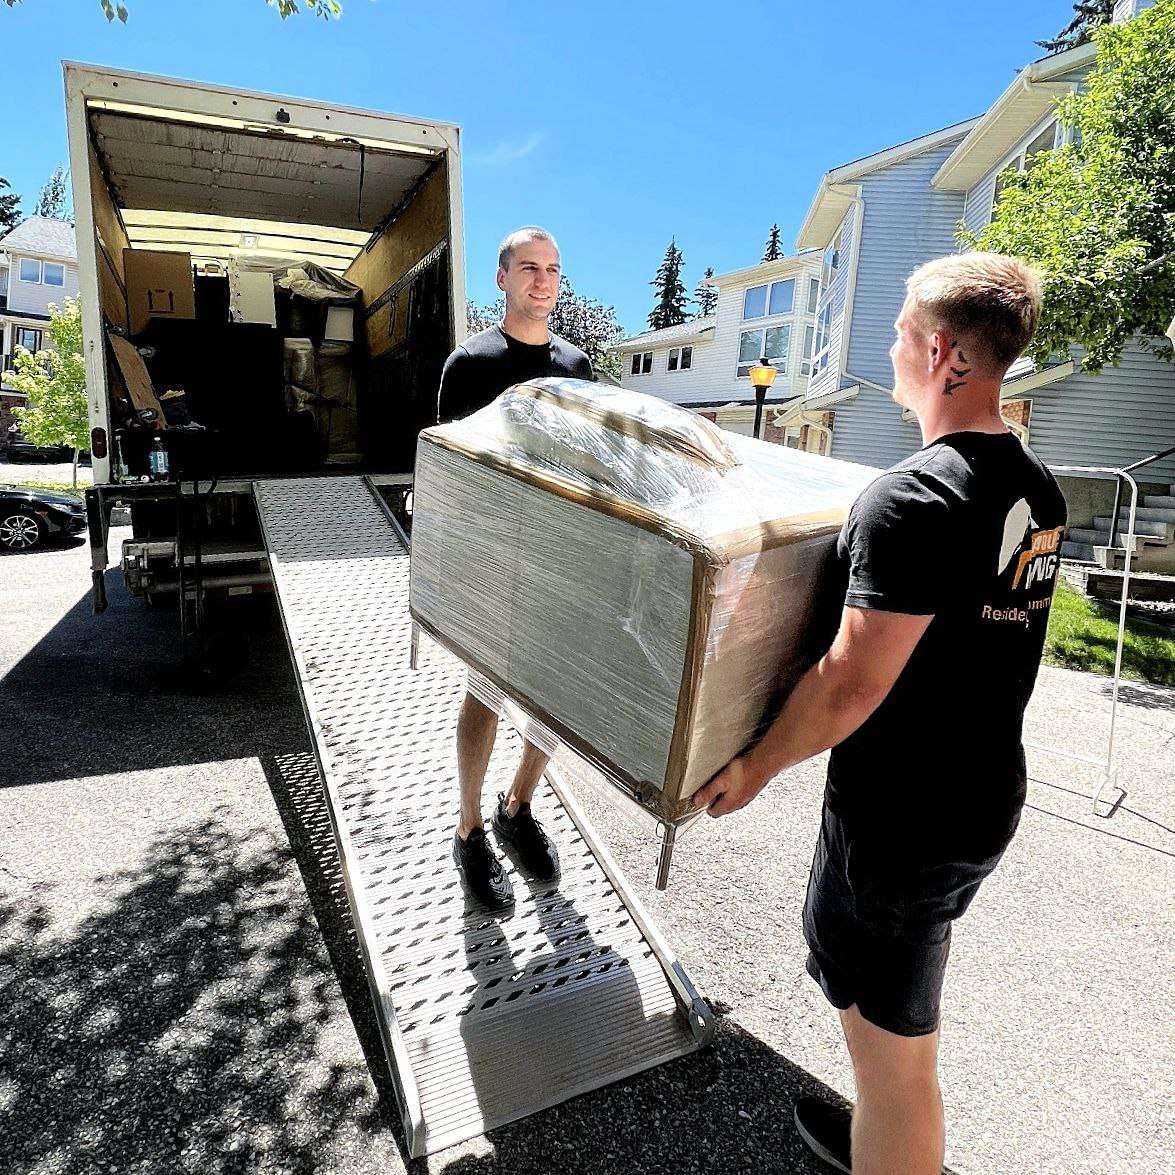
[5,298,89,489]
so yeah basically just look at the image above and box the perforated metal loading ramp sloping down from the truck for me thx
[254,477,713,1156]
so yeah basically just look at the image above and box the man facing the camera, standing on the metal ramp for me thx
[437,226,592,909]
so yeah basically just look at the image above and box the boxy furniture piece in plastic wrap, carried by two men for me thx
[410,380,878,820]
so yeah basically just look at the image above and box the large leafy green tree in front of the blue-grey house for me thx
[959,0,1175,371]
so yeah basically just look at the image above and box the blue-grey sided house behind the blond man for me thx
[797,9,1175,569]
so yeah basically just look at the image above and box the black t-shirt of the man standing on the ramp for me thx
[437,324,593,424]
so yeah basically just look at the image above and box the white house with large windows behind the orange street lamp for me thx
[613,254,827,449]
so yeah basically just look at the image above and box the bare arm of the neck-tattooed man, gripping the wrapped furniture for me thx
[694,606,933,817]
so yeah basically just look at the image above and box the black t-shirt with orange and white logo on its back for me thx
[827,432,1065,866]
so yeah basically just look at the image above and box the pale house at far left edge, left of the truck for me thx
[0,216,78,445]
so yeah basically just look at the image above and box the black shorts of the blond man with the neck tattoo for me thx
[804,805,954,1036]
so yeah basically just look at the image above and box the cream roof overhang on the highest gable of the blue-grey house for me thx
[931,42,1097,192]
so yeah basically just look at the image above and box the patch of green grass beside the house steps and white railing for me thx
[1045,580,1175,685]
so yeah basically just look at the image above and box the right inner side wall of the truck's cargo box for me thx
[343,161,454,470]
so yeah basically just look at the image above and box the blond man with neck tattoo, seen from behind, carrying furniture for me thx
[698,253,1065,1175]
